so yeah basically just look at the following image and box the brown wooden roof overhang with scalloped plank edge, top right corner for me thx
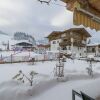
[61,0,100,31]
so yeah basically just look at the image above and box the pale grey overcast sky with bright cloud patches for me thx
[0,0,100,41]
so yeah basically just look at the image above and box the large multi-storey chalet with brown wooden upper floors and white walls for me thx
[47,28,91,57]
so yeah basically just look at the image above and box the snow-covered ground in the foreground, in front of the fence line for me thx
[0,59,100,100]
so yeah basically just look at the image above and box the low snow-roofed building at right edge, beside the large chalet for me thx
[87,43,100,56]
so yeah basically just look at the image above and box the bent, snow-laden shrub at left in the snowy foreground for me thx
[13,70,38,86]
